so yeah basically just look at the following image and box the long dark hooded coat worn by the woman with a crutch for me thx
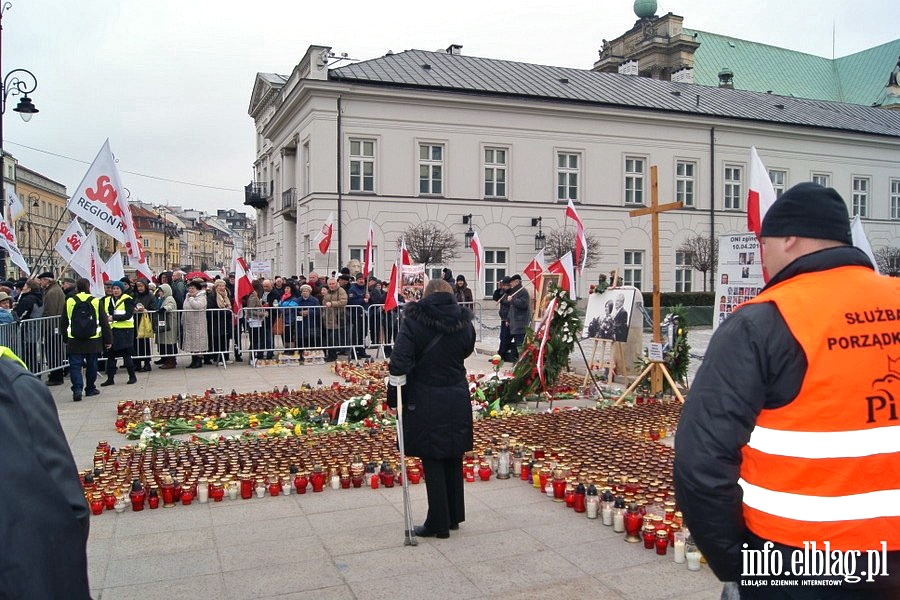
[390,292,475,460]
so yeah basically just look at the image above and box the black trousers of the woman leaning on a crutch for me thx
[422,456,466,533]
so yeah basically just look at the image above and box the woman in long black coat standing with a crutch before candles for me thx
[390,279,475,538]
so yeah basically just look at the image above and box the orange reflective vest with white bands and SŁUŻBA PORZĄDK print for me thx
[739,266,900,551]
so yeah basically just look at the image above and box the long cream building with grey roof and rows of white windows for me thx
[245,46,900,297]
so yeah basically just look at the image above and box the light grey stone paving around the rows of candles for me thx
[50,332,721,600]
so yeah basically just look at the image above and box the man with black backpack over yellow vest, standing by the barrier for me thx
[61,278,115,402]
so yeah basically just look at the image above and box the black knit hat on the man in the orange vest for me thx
[759,182,853,245]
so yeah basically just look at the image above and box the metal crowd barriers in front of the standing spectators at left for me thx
[0,302,484,375]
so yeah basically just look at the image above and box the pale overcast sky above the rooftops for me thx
[0,0,900,213]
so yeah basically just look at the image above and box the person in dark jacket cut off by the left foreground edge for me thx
[0,346,90,600]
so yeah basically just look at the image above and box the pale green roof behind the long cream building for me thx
[684,29,900,106]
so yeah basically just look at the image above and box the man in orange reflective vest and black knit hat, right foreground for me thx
[674,183,900,599]
